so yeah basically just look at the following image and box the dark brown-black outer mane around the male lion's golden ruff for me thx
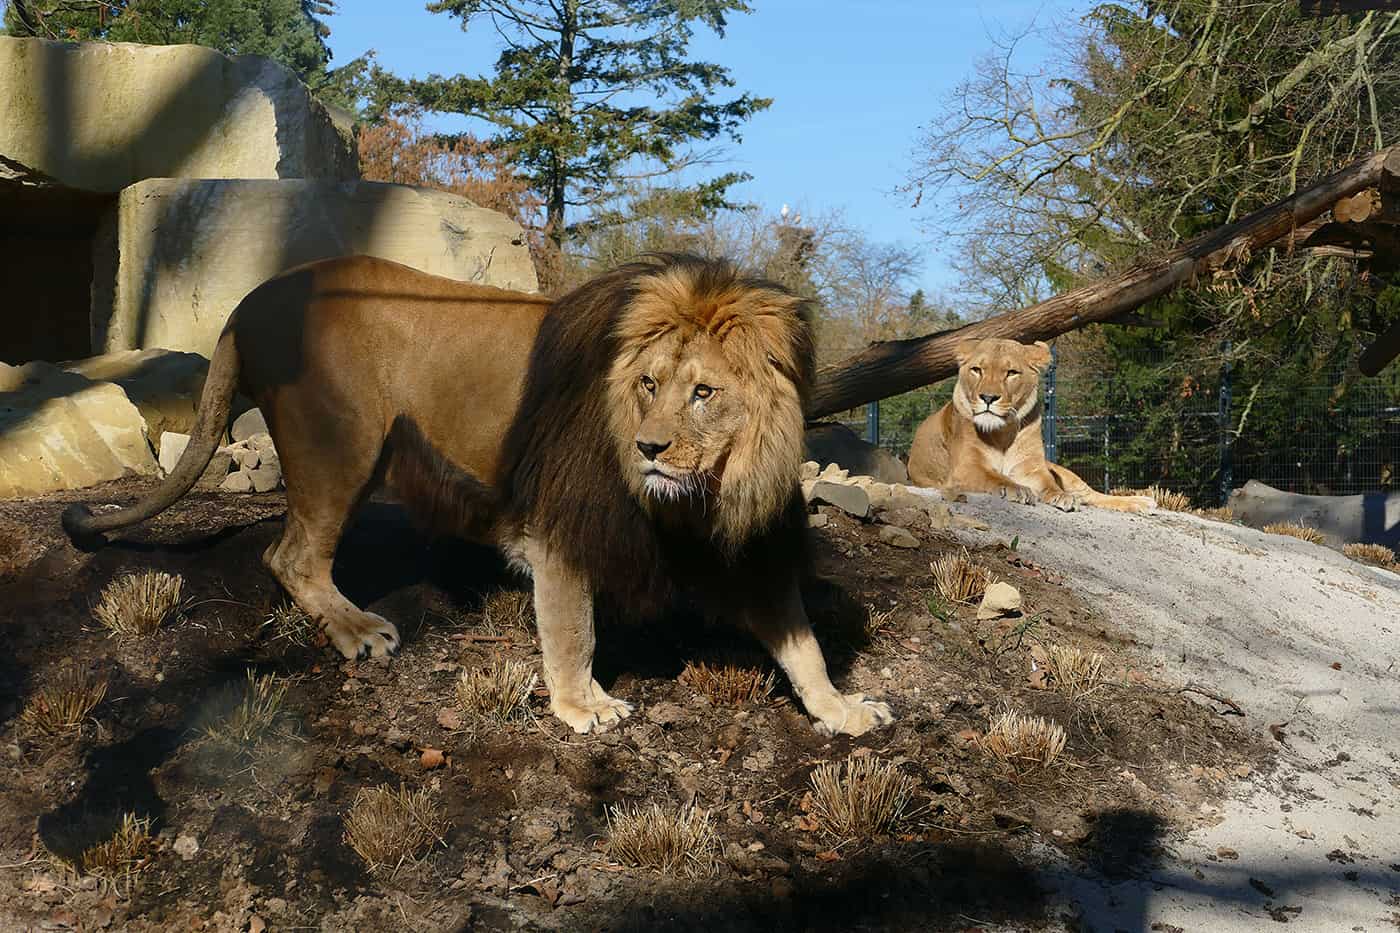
[501,254,812,615]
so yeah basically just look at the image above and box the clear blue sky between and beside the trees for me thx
[328,0,1086,293]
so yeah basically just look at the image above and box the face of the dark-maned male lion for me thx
[633,335,748,502]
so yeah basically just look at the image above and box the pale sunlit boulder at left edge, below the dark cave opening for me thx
[0,363,157,499]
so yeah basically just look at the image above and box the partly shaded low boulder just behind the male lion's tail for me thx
[63,350,209,438]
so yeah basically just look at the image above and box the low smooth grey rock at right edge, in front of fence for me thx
[1228,479,1400,549]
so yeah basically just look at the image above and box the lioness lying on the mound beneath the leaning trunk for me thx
[909,338,1156,511]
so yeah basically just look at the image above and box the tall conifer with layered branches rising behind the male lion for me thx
[375,0,771,247]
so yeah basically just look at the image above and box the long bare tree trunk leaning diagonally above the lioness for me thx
[808,147,1400,419]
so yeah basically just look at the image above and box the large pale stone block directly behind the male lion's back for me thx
[92,178,538,356]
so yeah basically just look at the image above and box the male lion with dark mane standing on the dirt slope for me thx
[63,255,892,735]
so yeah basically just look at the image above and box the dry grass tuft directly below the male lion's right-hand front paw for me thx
[812,755,914,839]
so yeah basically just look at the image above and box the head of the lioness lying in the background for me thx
[953,338,1050,433]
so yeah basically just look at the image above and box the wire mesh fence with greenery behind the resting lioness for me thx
[837,343,1400,506]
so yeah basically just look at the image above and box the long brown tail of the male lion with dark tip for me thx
[63,328,238,544]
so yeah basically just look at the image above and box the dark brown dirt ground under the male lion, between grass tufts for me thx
[0,482,1274,932]
